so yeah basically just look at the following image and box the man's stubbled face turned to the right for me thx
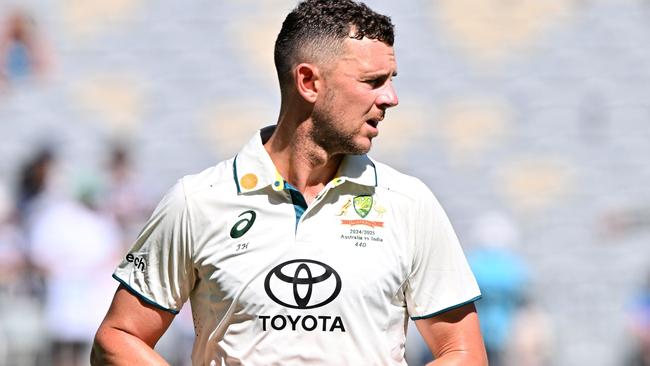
[311,38,398,155]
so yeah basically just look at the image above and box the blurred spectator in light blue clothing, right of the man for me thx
[467,213,528,366]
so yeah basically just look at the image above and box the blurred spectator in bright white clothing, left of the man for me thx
[29,174,121,365]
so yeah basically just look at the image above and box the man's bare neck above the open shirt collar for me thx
[264,108,343,203]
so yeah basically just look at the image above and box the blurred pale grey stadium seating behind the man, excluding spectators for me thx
[0,0,650,366]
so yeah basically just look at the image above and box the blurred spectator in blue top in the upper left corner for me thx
[0,9,50,90]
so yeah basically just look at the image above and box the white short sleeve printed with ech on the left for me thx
[113,180,194,314]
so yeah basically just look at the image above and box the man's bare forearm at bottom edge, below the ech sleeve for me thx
[90,328,168,366]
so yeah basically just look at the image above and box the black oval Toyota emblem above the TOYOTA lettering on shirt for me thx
[264,259,341,309]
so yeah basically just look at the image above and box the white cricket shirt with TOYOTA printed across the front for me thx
[113,127,480,365]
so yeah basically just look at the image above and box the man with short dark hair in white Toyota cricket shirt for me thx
[92,0,486,365]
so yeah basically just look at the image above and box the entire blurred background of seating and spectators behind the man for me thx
[0,0,650,366]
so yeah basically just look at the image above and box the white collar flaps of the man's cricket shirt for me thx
[233,126,377,193]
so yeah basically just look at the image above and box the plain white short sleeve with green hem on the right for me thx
[405,188,481,320]
